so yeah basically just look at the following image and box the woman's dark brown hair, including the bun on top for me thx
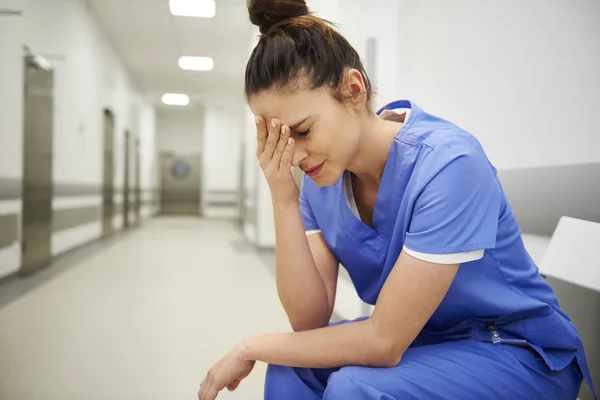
[245,0,372,104]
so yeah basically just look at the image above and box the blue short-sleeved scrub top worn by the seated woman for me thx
[300,101,593,394]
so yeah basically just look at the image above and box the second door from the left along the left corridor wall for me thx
[102,109,115,236]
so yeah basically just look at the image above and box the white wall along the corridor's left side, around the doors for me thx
[0,0,156,272]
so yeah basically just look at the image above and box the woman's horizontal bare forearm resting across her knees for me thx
[245,319,400,368]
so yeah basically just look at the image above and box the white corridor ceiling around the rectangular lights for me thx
[88,0,253,106]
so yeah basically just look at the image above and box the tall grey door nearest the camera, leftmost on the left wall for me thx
[20,55,54,275]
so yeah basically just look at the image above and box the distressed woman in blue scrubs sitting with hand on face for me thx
[198,0,591,400]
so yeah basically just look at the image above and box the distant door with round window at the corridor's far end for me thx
[160,153,201,216]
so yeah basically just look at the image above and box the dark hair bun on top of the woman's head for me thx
[248,0,309,34]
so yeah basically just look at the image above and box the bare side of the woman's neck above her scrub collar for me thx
[348,111,403,189]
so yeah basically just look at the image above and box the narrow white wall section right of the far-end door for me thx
[202,105,244,218]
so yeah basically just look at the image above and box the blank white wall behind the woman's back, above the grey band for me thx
[397,0,600,169]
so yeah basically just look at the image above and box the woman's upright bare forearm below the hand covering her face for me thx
[273,203,331,330]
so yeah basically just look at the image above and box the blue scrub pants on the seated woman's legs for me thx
[265,332,583,400]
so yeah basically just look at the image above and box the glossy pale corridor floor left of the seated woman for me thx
[0,218,288,400]
